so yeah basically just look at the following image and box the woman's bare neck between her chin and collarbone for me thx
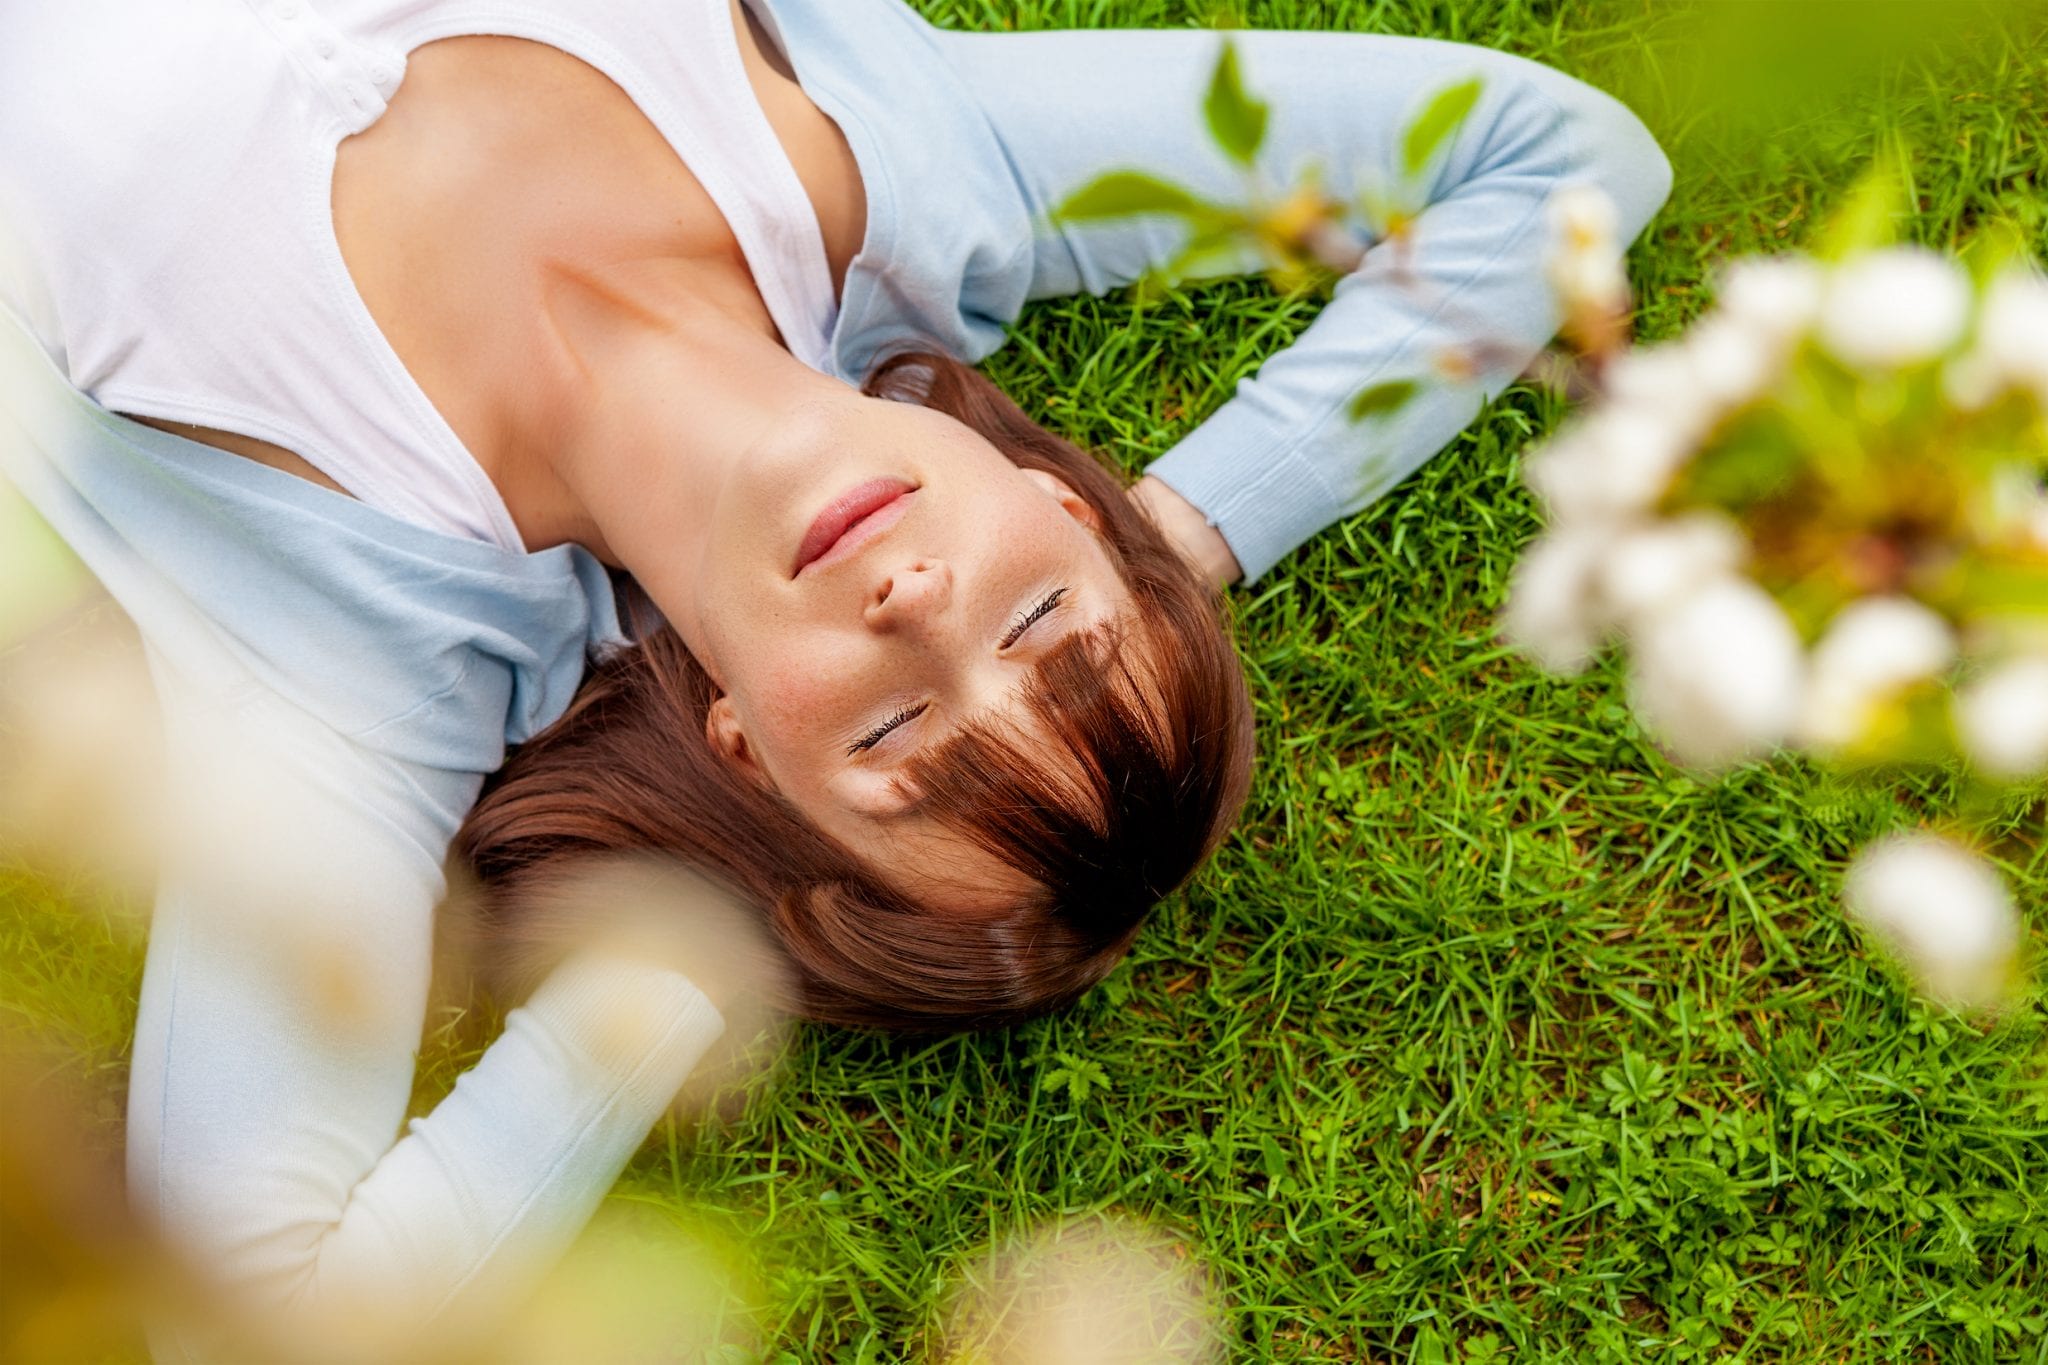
[500,258,846,573]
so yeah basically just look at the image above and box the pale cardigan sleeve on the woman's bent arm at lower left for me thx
[127,657,723,1359]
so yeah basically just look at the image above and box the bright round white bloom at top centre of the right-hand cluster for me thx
[1821,246,1970,370]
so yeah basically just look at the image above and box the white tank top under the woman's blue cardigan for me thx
[0,0,836,551]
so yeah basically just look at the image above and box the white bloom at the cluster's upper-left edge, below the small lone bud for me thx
[1524,405,1696,522]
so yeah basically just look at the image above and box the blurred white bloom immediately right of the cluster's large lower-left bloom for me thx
[1800,598,1956,751]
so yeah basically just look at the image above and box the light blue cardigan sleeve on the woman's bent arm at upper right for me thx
[936,31,1671,579]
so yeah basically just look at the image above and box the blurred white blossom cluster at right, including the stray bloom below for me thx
[1501,180,2048,1005]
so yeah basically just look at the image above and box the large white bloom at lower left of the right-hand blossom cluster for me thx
[1630,577,1804,767]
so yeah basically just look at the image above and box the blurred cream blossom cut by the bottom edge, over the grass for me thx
[938,1218,1223,1365]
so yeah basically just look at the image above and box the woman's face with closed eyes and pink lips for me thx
[664,391,1130,911]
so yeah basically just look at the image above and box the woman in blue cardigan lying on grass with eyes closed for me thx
[0,0,1669,1355]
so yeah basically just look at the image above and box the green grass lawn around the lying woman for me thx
[0,0,2048,1363]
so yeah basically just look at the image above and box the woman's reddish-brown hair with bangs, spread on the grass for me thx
[455,352,1251,1029]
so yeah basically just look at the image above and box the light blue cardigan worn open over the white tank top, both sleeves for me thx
[0,0,1669,1357]
